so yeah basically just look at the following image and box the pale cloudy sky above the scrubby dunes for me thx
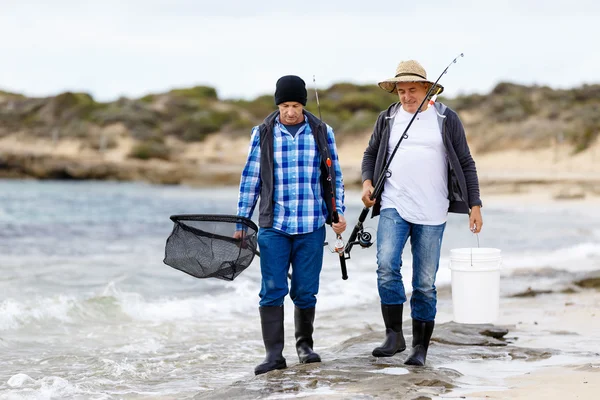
[0,0,600,101]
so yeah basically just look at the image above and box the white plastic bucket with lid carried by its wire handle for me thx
[450,248,502,324]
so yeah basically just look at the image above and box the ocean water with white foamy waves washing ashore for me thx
[0,180,600,399]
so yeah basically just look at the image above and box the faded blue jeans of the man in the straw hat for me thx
[377,208,446,321]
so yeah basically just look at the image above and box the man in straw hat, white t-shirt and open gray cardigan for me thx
[362,60,483,365]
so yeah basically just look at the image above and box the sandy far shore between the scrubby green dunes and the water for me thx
[0,130,600,199]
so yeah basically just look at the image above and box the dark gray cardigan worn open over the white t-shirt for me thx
[362,103,481,217]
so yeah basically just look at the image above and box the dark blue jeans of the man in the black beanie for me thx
[258,226,325,309]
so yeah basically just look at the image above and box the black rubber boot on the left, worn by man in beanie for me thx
[254,306,287,375]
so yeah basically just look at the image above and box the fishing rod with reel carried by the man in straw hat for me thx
[344,53,464,260]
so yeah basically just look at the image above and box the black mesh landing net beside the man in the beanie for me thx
[163,215,258,281]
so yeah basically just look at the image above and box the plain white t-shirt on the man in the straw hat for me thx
[381,107,448,225]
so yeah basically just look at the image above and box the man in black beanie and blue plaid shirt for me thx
[235,75,346,375]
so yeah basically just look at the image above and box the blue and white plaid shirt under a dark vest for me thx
[237,117,345,235]
